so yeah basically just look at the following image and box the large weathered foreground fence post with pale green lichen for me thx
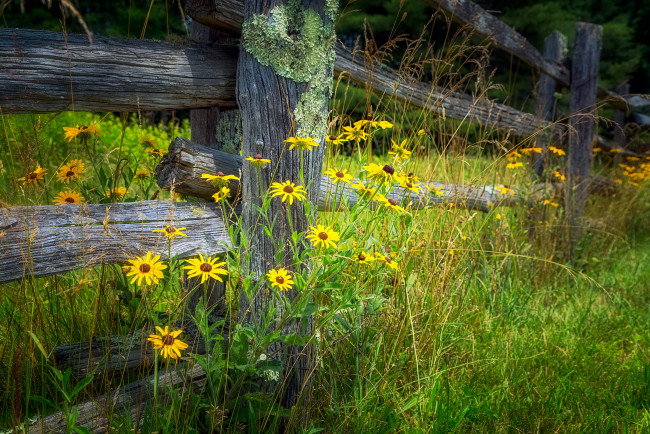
[237,0,337,418]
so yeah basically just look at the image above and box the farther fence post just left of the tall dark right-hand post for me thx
[533,30,567,177]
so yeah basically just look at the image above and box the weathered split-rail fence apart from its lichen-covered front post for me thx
[0,0,650,431]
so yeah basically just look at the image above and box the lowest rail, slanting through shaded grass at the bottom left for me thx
[27,364,205,434]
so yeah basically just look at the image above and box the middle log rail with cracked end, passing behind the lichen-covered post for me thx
[156,137,520,212]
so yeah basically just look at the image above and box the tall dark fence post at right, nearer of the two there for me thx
[565,23,603,254]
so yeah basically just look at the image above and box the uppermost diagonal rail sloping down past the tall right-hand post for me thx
[424,0,650,110]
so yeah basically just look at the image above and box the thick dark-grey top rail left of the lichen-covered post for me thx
[0,29,238,113]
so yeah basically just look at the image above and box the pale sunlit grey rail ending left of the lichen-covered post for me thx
[0,201,231,283]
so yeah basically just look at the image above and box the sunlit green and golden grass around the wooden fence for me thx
[0,104,650,433]
